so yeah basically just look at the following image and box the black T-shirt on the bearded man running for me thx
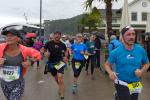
[44,41,67,63]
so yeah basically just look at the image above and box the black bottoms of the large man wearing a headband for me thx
[115,84,138,100]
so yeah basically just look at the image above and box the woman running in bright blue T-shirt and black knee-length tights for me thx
[71,34,88,94]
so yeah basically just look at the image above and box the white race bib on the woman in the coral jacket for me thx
[0,66,21,82]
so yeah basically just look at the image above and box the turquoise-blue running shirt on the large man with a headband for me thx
[108,44,149,82]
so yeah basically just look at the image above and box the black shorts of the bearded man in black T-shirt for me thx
[48,63,66,76]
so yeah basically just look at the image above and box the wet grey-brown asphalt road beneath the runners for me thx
[0,61,150,100]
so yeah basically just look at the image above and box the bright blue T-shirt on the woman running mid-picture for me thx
[71,43,87,60]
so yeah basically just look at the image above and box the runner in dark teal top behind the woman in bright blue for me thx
[86,35,96,80]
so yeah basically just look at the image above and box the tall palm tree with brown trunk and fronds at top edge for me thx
[85,0,118,37]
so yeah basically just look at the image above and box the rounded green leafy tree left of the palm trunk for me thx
[80,7,102,32]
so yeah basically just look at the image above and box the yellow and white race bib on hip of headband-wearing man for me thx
[128,82,143,94]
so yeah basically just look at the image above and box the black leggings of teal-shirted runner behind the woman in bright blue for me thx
[86,55,96,75]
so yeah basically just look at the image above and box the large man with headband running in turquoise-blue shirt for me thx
[105,26,149,100]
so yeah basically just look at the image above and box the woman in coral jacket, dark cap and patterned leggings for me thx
[0,29,41,100]
